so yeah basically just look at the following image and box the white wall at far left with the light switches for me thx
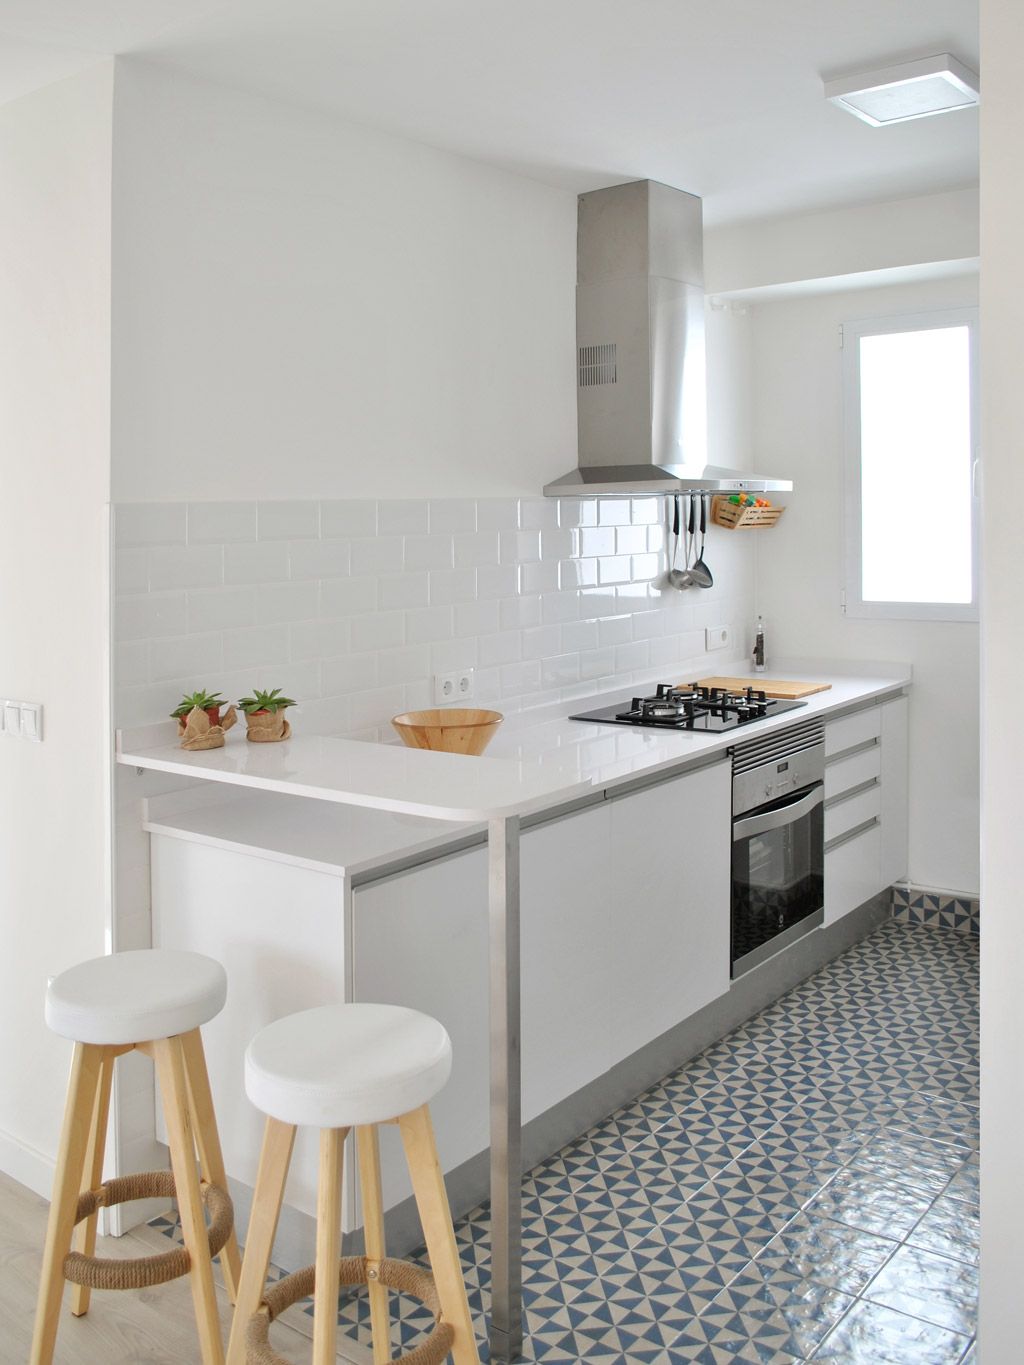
[0,63,112,1193]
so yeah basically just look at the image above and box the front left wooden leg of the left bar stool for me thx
[29,1043,104,1365]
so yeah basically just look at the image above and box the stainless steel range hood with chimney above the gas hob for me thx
[543,180,793,497]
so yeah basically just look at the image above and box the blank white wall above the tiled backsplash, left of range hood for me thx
[113,60,576,501]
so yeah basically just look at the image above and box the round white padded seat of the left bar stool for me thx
[46,949,228,1043]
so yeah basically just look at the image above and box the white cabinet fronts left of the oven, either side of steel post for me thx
[352,762,730,1207]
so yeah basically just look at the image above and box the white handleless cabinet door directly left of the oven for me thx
[609,760,732,1062]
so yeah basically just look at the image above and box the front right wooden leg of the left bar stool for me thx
[153,1037,224,1365]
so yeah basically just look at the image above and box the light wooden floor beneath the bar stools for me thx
[0,1173,370,1365]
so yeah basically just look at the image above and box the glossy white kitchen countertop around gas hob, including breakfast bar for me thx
[117,663,911,875]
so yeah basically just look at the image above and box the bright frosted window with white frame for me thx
[842,308,978,621]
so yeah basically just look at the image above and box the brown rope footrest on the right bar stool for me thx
[246,1256,455,1365]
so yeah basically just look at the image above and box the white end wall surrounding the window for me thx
[754,277,979,894]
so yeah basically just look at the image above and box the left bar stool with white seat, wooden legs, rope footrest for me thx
[30,949,240,1365]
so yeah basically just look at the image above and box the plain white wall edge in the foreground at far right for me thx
[979,0,1024,1348]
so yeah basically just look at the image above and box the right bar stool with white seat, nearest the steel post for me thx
[228,1005,479,1365]
